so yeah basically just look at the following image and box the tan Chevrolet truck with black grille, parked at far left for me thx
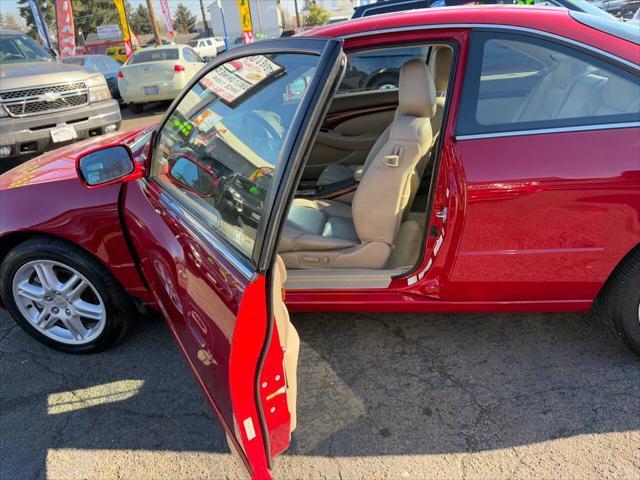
[0,30,121,158]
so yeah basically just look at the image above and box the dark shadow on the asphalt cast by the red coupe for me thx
[0,313,640,478]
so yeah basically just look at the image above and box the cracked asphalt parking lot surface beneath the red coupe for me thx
[0,306,640,479]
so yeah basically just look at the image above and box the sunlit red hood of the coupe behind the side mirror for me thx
[0,127,155,190]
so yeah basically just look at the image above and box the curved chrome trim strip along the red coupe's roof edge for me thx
[340,23,640,72]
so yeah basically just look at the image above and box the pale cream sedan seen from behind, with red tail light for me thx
[118,45,205,113]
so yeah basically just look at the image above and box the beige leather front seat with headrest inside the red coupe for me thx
[279,59,436,269]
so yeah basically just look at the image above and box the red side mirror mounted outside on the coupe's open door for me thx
[77,145,143,188]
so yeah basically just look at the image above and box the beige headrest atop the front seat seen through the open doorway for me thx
[397,58,436,117]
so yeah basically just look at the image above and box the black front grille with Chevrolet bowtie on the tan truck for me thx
[0,82,89,117]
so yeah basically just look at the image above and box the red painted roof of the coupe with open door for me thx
[301,5,640,64]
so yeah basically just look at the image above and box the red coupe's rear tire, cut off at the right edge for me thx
[603,250,640,356]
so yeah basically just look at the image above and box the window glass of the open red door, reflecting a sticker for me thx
[151,54,319,258]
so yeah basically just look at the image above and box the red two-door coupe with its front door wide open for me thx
[0,7,640,478]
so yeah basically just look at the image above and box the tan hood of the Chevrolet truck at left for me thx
[0,62,95,90]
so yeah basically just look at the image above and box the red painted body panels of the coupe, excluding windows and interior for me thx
[0,7,640,477]
